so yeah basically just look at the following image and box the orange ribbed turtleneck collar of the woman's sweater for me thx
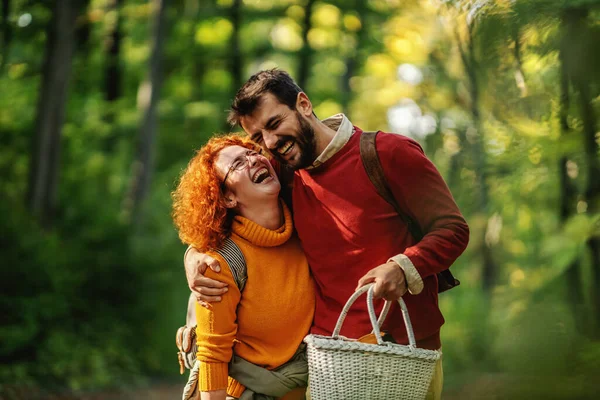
[231,201,294,247]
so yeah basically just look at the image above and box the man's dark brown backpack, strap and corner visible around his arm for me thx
[360,131,460,293]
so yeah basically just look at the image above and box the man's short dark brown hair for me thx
[227,68,303,126]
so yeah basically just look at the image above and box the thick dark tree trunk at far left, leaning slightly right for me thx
[27,0,77,227]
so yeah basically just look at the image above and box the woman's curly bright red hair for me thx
[171,134,258,251]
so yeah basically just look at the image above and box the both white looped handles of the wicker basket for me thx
[331,283,417,348]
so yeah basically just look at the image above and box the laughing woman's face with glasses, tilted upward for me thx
[215,146,281,207]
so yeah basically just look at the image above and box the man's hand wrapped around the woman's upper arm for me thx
[183,247,228,308]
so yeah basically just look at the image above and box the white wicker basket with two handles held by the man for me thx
[304,284,441,400]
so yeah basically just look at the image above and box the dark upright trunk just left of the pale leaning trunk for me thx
[104,0,123,102]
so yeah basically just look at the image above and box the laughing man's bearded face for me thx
[241,93,317,169]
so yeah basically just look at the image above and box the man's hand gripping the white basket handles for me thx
[356,261,407,301]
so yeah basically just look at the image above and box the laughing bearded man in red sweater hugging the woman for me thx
[184,70,469,398]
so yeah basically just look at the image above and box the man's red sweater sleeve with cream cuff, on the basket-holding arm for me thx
[377,133,469,286]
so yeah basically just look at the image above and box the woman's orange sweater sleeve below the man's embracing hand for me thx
[196,253,241,392]
